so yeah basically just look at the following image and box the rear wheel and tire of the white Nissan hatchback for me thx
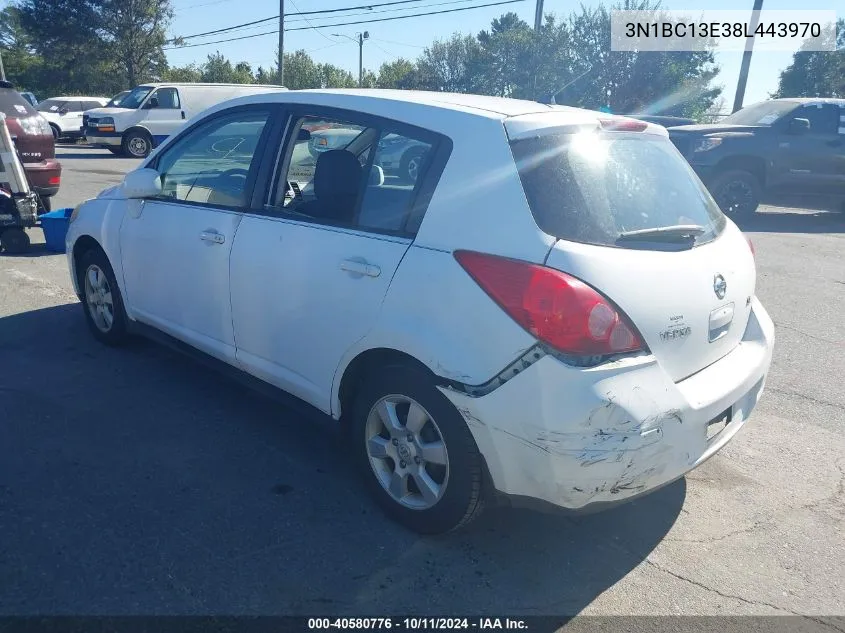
[350,363,486,534]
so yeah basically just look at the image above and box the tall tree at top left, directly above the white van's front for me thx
[100,0,173,88]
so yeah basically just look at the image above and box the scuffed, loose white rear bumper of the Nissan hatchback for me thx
[441,299,774,511]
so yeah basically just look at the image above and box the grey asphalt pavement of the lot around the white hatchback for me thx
[0,146,845,616]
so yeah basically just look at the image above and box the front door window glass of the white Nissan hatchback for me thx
[156,112,270,208]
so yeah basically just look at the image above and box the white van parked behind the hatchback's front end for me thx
[82,83,285,158]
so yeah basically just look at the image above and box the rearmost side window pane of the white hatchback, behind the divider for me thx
[358,133,432,231]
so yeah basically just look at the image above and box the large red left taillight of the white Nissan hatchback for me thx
[455,251,644,356]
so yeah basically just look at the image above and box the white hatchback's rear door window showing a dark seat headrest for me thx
[273,117,368,223]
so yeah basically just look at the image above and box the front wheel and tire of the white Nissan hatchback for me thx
[77,248,129,346]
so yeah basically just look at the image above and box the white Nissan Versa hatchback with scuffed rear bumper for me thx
[67,91,774,533]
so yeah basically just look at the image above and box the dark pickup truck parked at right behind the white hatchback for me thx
[669,99,845,216]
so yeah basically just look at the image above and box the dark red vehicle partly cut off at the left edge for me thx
[0,81,62,211]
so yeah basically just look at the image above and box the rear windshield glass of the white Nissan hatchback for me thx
[511,131,725,248]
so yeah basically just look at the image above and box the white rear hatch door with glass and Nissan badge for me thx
[511,118,756,381]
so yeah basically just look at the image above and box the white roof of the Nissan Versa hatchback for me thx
[243,89,568,119]
